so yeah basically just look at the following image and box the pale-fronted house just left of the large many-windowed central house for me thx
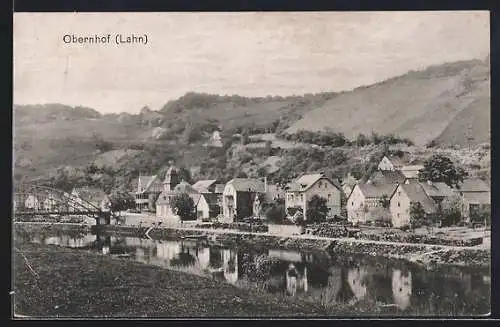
[222,178,265,222]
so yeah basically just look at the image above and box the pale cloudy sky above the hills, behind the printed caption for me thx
[14,11,490,113]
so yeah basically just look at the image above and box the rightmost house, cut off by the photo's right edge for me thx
[455,179,491,222]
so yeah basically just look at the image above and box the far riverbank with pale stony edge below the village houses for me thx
[93,225,491,268]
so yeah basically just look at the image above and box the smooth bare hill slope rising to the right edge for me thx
[287,60,490,145]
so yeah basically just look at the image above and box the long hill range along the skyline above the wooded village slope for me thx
[14,58,490,149]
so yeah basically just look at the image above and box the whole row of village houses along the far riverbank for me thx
[131,156,491,227]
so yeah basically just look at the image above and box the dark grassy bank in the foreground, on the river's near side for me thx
[14,244,339,317]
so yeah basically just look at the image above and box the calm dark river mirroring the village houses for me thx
[16,230,491,316]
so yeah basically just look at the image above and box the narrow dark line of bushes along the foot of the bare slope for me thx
[278,128,414,147]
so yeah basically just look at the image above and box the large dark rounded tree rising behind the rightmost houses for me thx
[418,154,468,187]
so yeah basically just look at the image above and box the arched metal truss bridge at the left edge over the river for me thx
[12,183,113,224]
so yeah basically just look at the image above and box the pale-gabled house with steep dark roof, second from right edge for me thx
[390,183,438,228]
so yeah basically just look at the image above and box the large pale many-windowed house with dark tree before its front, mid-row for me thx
[285,174,343,220]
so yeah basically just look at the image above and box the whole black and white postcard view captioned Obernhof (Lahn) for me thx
[10,11,491,320]
